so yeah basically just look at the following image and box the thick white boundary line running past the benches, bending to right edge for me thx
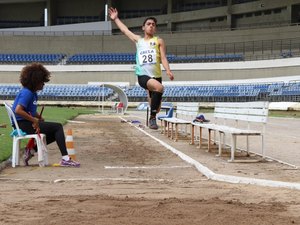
[120,117,300,190]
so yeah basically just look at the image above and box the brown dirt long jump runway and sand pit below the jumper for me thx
[0,111,300,225]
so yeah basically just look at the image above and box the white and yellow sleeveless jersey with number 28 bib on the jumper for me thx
[135,36,161,77]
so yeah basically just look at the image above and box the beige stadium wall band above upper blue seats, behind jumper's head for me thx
[0,26,300,55]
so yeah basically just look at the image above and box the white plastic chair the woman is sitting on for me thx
[4,102,48,167]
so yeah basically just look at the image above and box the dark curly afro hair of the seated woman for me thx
[20,63,50,91]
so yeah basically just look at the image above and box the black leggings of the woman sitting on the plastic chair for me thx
[18,120,68,156]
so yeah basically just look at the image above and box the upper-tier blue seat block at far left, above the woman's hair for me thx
[0,54,65,65]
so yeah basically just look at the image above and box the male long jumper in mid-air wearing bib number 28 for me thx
[109,8,174,129]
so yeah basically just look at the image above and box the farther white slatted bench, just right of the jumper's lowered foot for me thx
[161,102,199,141]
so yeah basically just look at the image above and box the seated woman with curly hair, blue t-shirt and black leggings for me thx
[12,63,80,167]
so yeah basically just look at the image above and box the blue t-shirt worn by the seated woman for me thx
[12,88,38,120]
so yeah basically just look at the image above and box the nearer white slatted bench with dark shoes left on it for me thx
[191,102,269,161]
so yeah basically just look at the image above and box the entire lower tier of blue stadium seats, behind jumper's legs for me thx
[0,82,300,102]
